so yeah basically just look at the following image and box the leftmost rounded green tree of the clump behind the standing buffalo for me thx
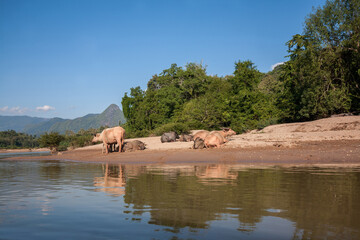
[122,63,208,135]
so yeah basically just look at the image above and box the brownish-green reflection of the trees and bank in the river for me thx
[94,164,360,239]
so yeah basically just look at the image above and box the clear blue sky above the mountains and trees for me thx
[0,0,325,119]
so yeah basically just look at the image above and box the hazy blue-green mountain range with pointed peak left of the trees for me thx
[0,104,126,135]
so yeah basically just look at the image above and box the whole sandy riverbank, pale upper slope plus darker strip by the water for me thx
[2,116,360,167]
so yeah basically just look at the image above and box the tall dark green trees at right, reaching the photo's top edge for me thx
[279,0,360,121]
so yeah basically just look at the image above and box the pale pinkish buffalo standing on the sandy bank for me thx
[92,127,125,154]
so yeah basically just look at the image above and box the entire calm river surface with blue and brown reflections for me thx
[0,160,360,239]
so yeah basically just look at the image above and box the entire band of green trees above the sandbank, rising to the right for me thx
[122,0,360,136]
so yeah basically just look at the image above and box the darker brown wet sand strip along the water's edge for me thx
[6,140,360,168]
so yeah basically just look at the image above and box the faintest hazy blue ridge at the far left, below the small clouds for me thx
[0,116,49,132]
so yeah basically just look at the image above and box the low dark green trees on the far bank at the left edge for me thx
[0,130,39,149]
